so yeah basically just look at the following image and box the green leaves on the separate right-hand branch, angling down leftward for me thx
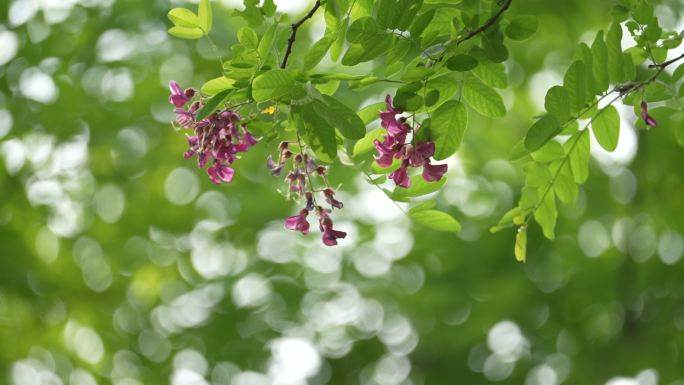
[492,0,684,261]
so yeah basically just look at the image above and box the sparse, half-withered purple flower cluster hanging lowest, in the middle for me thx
[274,142,347,246]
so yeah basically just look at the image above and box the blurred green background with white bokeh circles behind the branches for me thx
[0,0,684,385]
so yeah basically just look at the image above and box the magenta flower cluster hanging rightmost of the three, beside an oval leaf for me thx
[374,95,448,188]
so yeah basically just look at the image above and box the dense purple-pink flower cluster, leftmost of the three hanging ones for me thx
[169,81,257,184]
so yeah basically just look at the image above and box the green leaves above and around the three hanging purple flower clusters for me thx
[169,0,537,231]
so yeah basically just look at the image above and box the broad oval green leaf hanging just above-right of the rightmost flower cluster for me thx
[430,100,468,160]
